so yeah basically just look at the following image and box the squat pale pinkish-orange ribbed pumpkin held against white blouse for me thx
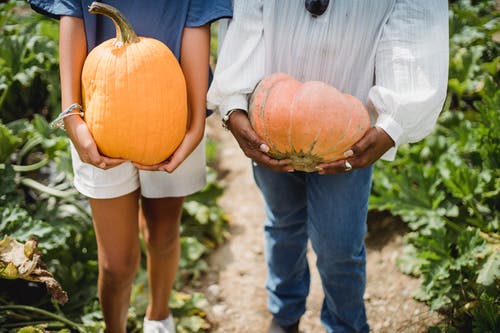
[249,73,370,172]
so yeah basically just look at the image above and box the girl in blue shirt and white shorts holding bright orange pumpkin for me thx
[30,0,232,333]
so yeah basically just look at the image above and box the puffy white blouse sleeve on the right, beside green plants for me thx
[368,0,449,160]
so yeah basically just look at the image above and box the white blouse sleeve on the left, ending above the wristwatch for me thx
[207,0,265,117]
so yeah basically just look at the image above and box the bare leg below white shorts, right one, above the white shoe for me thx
[139,197,184,320]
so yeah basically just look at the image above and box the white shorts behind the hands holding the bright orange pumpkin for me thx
[71,139,206,199]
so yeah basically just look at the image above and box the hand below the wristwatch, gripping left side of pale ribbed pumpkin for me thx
[226,110,293,172]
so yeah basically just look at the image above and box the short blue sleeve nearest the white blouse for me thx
[186,0,233,27]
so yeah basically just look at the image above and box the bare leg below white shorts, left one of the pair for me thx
[90,191,140,333]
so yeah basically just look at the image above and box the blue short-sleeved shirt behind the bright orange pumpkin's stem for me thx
[29,0,232,59]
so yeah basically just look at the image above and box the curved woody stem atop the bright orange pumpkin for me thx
[89,1,139,47]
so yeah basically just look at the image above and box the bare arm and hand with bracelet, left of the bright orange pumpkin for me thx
[59,16,123,169]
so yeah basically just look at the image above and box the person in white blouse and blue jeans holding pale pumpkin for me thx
[208,0,449,332]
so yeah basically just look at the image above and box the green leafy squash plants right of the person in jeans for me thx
[371,0,500,332]
